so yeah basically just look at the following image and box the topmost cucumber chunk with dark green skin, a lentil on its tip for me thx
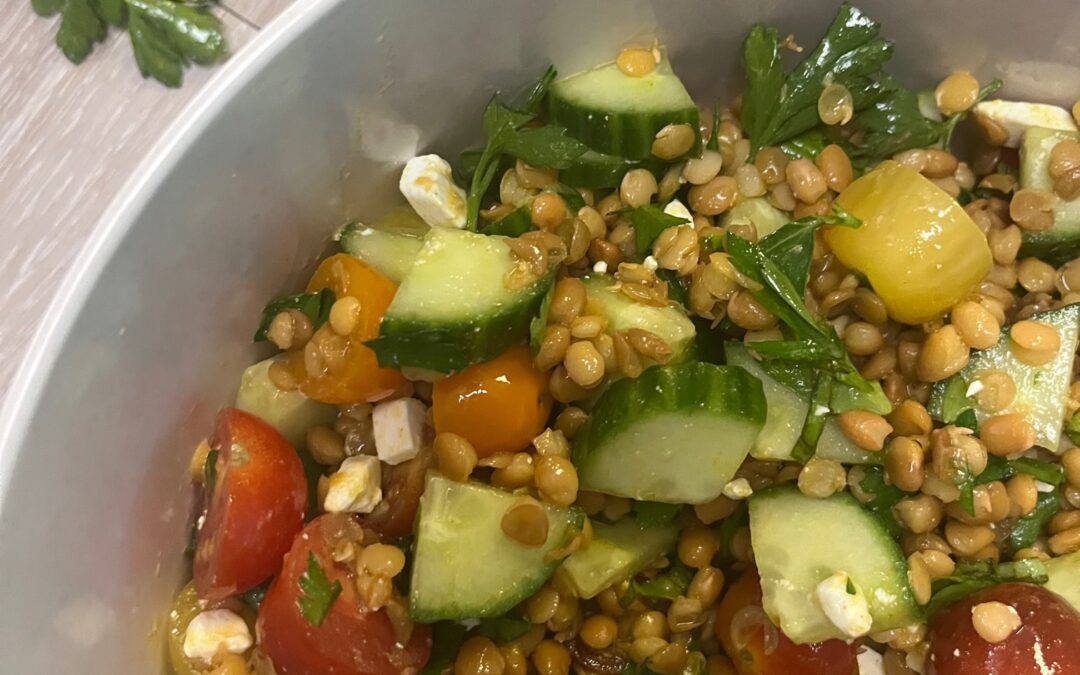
[548,58,701,160]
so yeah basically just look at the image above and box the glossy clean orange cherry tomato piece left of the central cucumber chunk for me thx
[431,345,552,457]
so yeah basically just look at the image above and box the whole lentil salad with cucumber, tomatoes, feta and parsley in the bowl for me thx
[168,4,1080,675]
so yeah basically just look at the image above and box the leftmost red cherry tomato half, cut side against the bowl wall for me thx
[194,408,308,600]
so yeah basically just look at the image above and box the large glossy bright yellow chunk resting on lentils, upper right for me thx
[825,161,993,324]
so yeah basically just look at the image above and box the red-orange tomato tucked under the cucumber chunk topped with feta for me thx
[716,570,859,675]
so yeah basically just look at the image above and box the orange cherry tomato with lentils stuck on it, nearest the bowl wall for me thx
[288,253,405,405]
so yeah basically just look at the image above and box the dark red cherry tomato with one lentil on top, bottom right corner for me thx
[930,583,1080,675]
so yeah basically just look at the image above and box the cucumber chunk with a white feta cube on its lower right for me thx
[750,485,921,645]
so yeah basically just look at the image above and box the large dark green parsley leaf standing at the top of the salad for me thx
[742,3,892,152]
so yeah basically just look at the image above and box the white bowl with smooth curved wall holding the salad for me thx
[0,0,1080,674]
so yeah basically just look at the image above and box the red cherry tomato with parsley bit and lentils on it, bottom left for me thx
[256,514,431,675]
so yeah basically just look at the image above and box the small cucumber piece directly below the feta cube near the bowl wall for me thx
[334,206,429,284]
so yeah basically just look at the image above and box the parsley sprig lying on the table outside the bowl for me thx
[31,0,226,86]
